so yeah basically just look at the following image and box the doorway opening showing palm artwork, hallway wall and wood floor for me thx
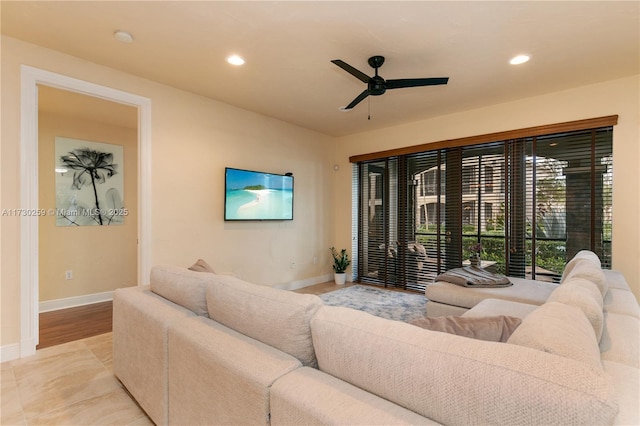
[38,85,138,349]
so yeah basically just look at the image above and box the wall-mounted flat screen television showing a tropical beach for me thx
[224,167,293,221]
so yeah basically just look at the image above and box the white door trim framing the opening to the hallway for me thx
[20,65,151,357]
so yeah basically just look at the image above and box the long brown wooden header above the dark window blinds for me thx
[349,115,618,163]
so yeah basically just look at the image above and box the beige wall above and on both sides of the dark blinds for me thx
[333,75,640,298]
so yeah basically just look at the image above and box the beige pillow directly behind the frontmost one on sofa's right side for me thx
[548,277,604,341]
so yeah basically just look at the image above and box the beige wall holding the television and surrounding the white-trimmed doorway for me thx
[0,36,334,345]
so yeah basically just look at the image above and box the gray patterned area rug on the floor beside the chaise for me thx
[320,285,427,322]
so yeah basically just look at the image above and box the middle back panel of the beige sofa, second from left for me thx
[169,317,302,425]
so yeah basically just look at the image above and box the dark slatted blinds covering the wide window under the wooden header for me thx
[354,121,613,291]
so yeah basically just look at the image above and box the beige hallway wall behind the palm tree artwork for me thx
[38,105,138,302]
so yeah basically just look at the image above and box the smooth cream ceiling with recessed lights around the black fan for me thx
[1,0,640,136]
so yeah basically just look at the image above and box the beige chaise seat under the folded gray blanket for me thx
[425,277,558,317]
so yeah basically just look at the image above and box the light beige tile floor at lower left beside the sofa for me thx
[0,333,153,426]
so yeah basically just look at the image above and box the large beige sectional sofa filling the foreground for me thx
[113,251,640,425]
